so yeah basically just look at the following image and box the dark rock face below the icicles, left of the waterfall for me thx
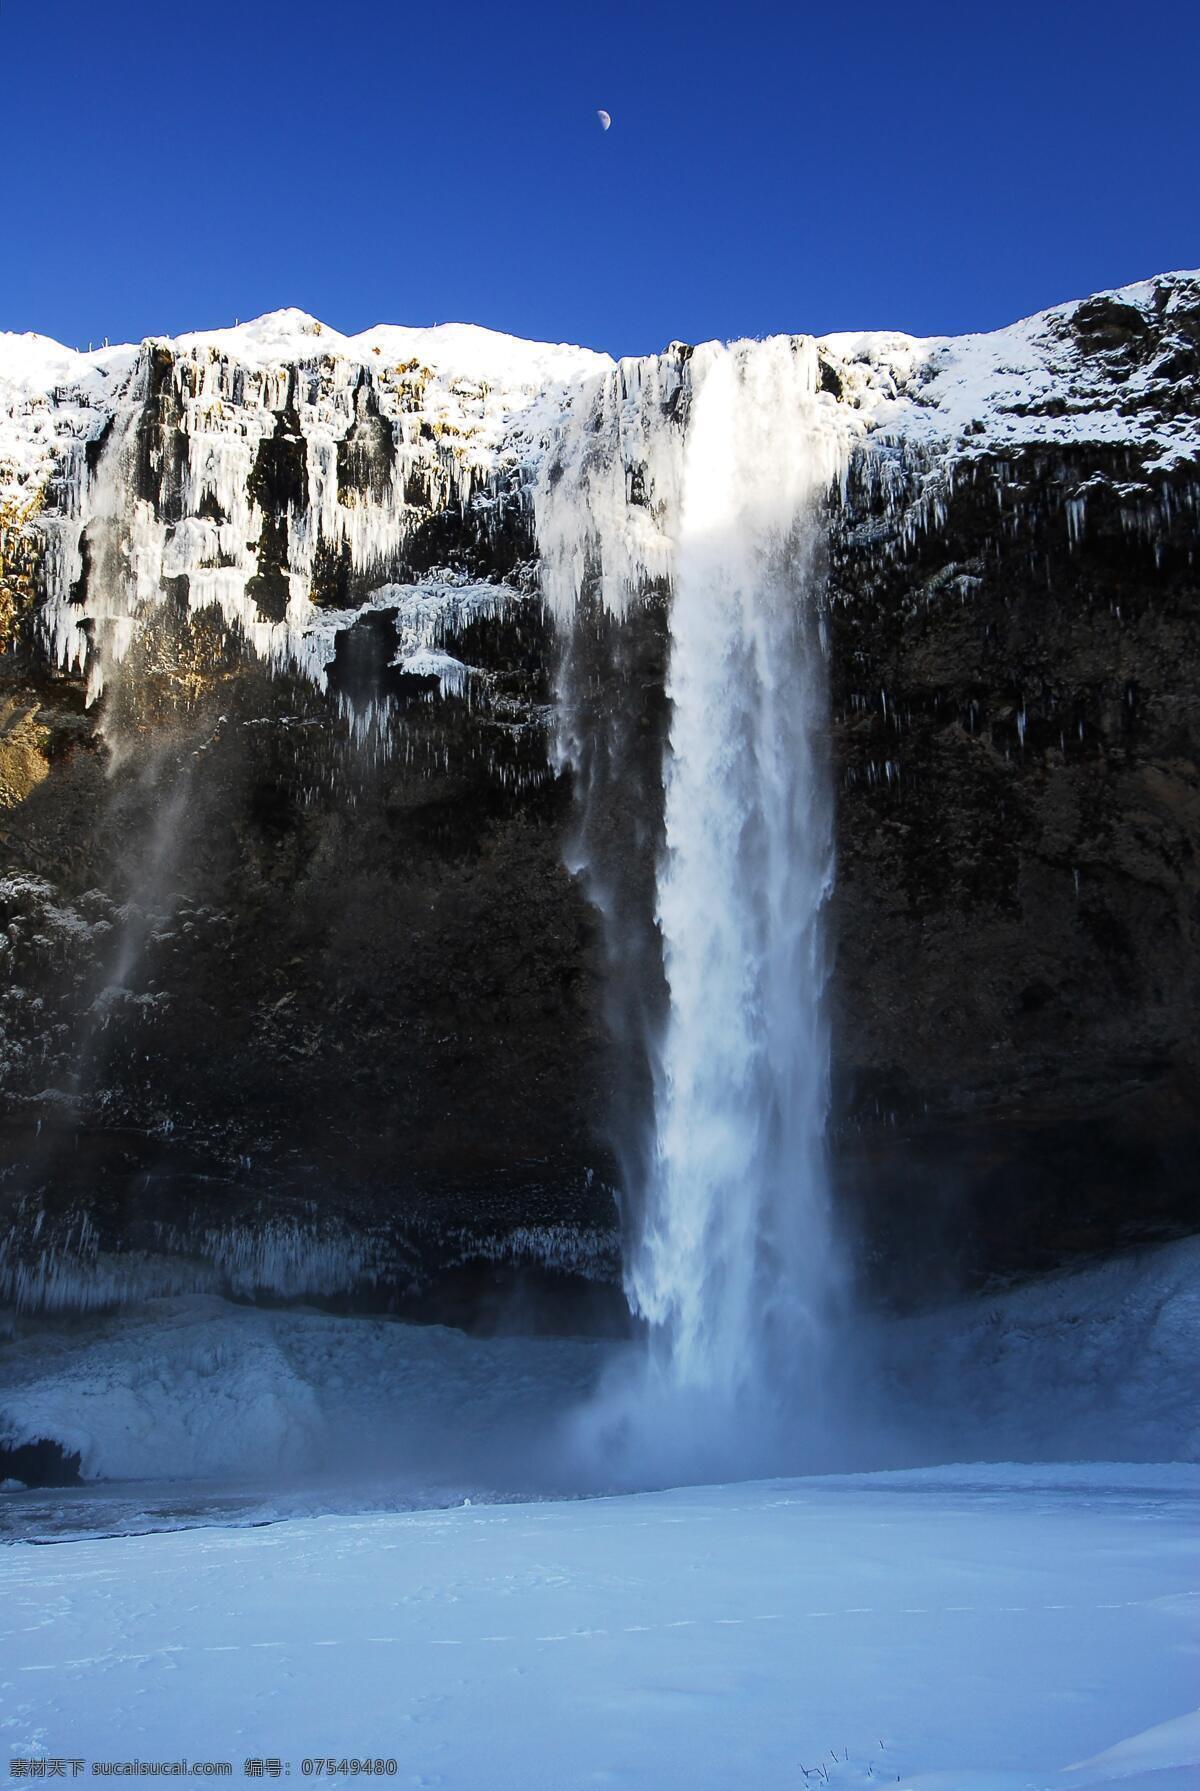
[0,604,614,1332]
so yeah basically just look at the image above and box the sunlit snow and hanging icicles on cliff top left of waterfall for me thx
[0,312,605,697]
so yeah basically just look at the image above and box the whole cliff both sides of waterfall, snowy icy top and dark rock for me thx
[0,276,1200,1316]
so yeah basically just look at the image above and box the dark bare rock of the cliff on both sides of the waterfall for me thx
[0,286,1200,1324]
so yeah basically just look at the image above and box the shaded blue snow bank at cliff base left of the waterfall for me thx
[0,1295,602,1479]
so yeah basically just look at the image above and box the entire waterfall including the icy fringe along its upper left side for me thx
[536,337,856,1468]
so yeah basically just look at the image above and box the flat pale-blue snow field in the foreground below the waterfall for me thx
[0,1467,1200,1791]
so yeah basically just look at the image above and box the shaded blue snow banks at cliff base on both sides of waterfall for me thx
[0,1239,1200,1494]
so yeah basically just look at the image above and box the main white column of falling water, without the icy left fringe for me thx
[644,342,833,1395]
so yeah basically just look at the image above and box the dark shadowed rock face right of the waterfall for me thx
[831,451,1200,1296]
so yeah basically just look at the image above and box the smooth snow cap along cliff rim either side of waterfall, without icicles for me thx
[0,270,1200,519]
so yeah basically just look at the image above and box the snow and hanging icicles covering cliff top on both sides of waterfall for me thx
[0,272,1200,709]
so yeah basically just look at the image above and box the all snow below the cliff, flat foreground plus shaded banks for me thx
[0,1239,1200,1791]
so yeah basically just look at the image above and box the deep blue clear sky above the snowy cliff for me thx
[0,0,1200,353]
